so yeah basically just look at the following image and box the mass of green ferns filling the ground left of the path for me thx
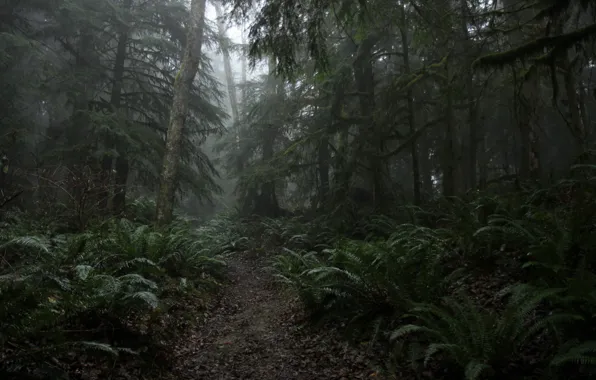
[0,212,237,378]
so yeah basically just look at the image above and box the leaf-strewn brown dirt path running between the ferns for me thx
[171,251,378,380]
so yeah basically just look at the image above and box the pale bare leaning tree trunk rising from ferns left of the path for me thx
[156,0,206,225]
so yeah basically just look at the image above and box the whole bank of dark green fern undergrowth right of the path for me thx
[258,167,596,380]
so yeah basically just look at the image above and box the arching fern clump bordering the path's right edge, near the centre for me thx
[272,226,447,341]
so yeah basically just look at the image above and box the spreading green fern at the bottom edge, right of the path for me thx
[391,287,580,380]
